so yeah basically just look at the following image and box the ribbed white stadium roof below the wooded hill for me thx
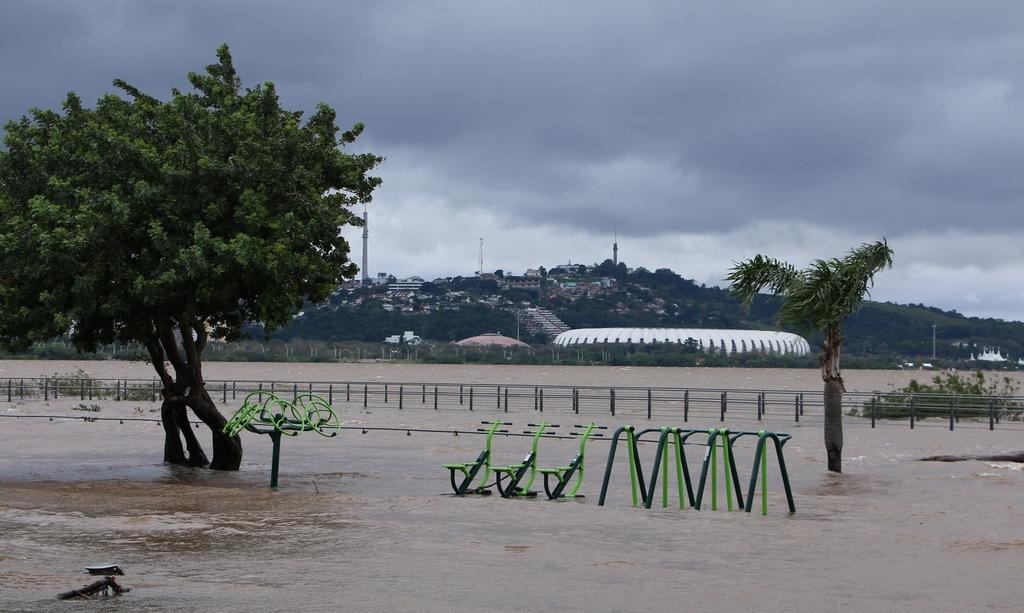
[555,327,811,355]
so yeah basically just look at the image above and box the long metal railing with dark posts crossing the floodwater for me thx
[0,377,1024,430]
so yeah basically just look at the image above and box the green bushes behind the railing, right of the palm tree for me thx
[850,370,1024,420]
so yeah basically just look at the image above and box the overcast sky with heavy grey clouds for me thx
[0,0,1024,320]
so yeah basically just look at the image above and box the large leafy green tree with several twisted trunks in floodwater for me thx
[0,46,382,470]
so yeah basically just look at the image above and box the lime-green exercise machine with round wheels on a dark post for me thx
[222,391,341,487]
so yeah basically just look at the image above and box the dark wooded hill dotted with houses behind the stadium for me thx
[273,261,1024,359]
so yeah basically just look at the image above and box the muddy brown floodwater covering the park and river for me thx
[0,361,1024,612]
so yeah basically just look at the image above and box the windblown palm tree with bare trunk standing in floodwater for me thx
[727,238,893,473]
